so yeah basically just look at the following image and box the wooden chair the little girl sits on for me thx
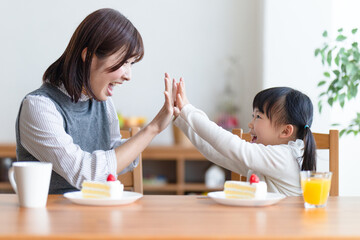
[231,128,339,196]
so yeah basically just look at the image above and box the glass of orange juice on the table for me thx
[300,171,332,208]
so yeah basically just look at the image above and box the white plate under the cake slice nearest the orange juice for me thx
[208,191,285,207]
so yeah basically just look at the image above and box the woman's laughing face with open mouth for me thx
[90,52,135,101]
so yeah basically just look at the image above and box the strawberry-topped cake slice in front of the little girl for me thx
[224,174,267,199]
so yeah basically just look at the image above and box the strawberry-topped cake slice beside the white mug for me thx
[81,174,124,198]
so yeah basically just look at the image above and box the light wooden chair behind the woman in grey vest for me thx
[118,127,143,194]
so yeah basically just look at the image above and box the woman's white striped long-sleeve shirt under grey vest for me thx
[19,87,138,189]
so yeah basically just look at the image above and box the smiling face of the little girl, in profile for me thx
[248,108,282,145]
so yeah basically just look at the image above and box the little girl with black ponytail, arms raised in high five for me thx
[173,79,316,196]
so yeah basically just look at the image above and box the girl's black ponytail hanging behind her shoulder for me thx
[301,125,316,171]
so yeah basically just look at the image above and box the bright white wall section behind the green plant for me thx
[263,0,360,195]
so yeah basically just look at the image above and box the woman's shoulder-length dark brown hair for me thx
[43,8,144,102]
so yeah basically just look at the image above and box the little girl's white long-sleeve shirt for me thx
[174,104,304,196]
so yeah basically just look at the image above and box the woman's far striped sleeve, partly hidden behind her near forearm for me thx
[106,97,139,174]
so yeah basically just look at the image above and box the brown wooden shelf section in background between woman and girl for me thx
[142,145,226,195]
